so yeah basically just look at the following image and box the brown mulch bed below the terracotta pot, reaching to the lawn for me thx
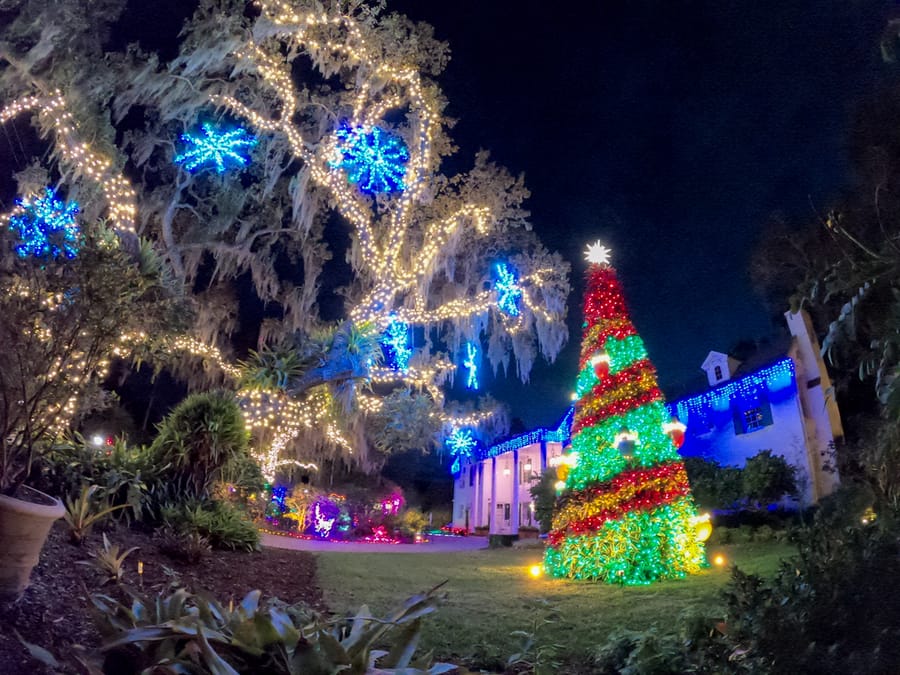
[0,521,324,675]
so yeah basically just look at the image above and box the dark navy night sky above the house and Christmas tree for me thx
[388,0,897,427]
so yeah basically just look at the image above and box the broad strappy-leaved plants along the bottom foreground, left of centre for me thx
[91,589,455,675]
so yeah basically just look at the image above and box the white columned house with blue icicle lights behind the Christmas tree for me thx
[453,312,843,534]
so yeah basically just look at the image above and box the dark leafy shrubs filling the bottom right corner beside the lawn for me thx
[597,513,900,674]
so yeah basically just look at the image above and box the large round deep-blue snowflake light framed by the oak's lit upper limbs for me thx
[331,126,409,195]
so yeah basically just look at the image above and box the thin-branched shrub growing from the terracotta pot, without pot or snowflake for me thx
[0,222,176,493]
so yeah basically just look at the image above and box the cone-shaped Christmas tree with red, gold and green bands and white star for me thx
[544,243,708,585]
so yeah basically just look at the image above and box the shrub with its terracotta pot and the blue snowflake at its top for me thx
[0,206,174,601]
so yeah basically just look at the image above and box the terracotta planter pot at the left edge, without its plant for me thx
[0,487,66,602]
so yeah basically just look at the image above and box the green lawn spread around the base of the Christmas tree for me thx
[317,542,793,670]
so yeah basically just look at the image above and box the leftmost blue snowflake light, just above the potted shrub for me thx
[9,188,81,260]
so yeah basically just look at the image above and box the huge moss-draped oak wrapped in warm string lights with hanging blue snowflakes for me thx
[0,0,569,475]
